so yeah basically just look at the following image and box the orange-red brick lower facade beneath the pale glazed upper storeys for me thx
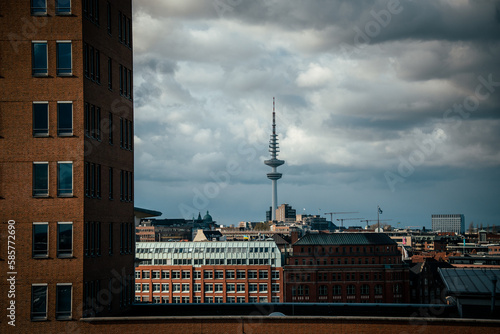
[135,265,283,304]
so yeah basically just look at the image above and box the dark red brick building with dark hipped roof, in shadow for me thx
[284,233,409,303]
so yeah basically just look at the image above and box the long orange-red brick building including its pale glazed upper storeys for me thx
[135,241,284,304]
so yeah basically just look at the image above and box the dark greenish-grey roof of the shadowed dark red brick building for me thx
[294,233,396,245]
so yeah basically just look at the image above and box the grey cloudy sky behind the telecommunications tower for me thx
[133,0,500,227]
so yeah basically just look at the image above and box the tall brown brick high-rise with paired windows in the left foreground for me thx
[0,0,134,332]
